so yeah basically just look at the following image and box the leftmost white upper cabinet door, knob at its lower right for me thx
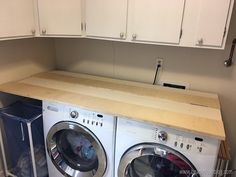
[0,0,35,38]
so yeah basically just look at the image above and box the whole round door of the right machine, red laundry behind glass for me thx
[118,144,199,177]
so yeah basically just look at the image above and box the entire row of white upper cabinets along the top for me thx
[0,0,234,49]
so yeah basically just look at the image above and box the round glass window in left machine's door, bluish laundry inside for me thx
[55,130,98,171]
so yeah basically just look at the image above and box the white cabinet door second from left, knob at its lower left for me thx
[38,0,81,36]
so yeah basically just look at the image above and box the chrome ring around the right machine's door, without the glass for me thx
[118,143,200,177]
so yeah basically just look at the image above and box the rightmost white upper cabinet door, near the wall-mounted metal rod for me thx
[195,0,230,46]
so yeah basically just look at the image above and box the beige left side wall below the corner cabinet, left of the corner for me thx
[0,39,55,106]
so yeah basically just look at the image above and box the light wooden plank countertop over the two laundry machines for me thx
[0,71,225,140]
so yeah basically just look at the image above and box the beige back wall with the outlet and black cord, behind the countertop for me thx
[55,3,236,168]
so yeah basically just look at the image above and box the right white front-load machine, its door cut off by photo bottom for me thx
[115,117,220,177]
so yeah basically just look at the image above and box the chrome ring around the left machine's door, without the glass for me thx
[46,121,107,177]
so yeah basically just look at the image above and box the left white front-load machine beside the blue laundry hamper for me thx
[43,101,116,177]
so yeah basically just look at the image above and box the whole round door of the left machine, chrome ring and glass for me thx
[46,121,107,177]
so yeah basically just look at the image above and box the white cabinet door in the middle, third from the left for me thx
[85,0,127,39]
